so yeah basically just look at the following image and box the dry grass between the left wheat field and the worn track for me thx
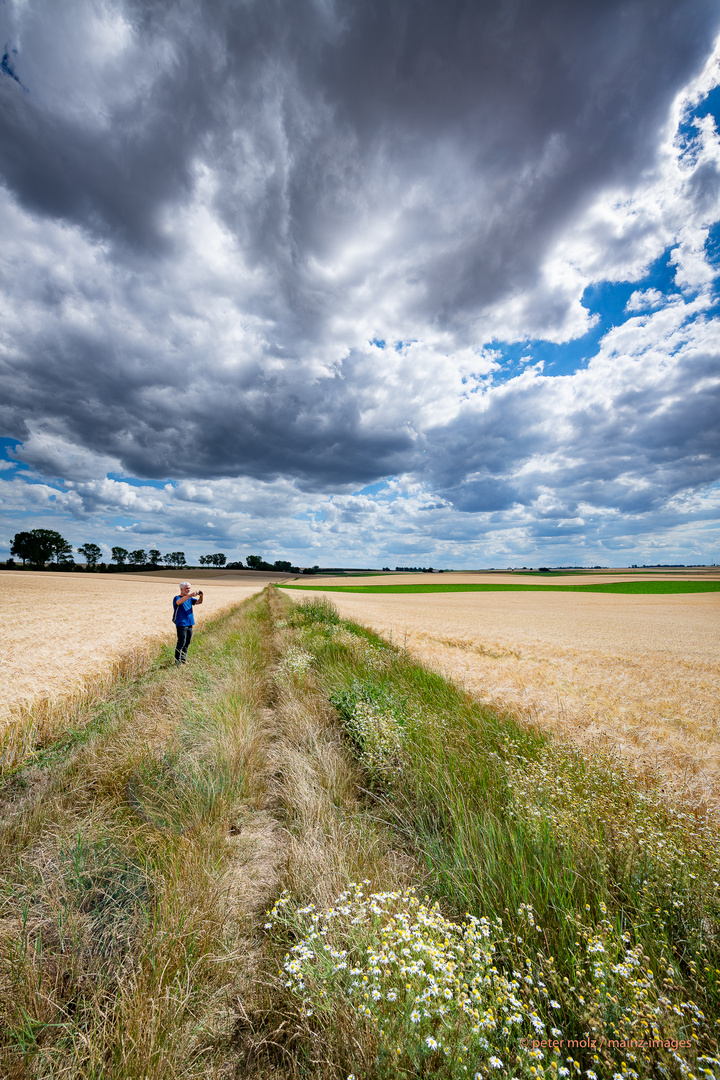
[0,596,276,1080]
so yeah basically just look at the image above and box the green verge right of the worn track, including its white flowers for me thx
[260,598,720,1080]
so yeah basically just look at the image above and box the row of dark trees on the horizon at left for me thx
[5,529,320,573]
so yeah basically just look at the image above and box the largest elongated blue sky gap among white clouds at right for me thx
[484,247,695,382]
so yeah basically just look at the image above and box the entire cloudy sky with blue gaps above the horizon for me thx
[0,0,720,567]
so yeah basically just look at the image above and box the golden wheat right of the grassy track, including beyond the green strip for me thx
[294,575,720,807]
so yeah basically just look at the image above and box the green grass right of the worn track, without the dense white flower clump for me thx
[268,597,720,1080]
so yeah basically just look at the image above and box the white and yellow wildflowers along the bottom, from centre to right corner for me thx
[266,881,720,1080]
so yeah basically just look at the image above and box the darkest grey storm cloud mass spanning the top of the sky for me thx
[0,0,720,282]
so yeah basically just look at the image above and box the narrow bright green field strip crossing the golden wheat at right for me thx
[280,581,720,595]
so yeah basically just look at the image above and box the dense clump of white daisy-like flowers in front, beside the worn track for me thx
[266,882,561,1077]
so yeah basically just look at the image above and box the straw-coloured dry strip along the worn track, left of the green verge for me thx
[235,591,418,1080]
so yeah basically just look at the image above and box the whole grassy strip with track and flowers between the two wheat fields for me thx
[0,589,720,1080]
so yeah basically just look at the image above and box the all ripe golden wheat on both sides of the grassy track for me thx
[5,570,720,807]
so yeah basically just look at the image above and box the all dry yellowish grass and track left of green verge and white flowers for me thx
[0,594,403,1080]
